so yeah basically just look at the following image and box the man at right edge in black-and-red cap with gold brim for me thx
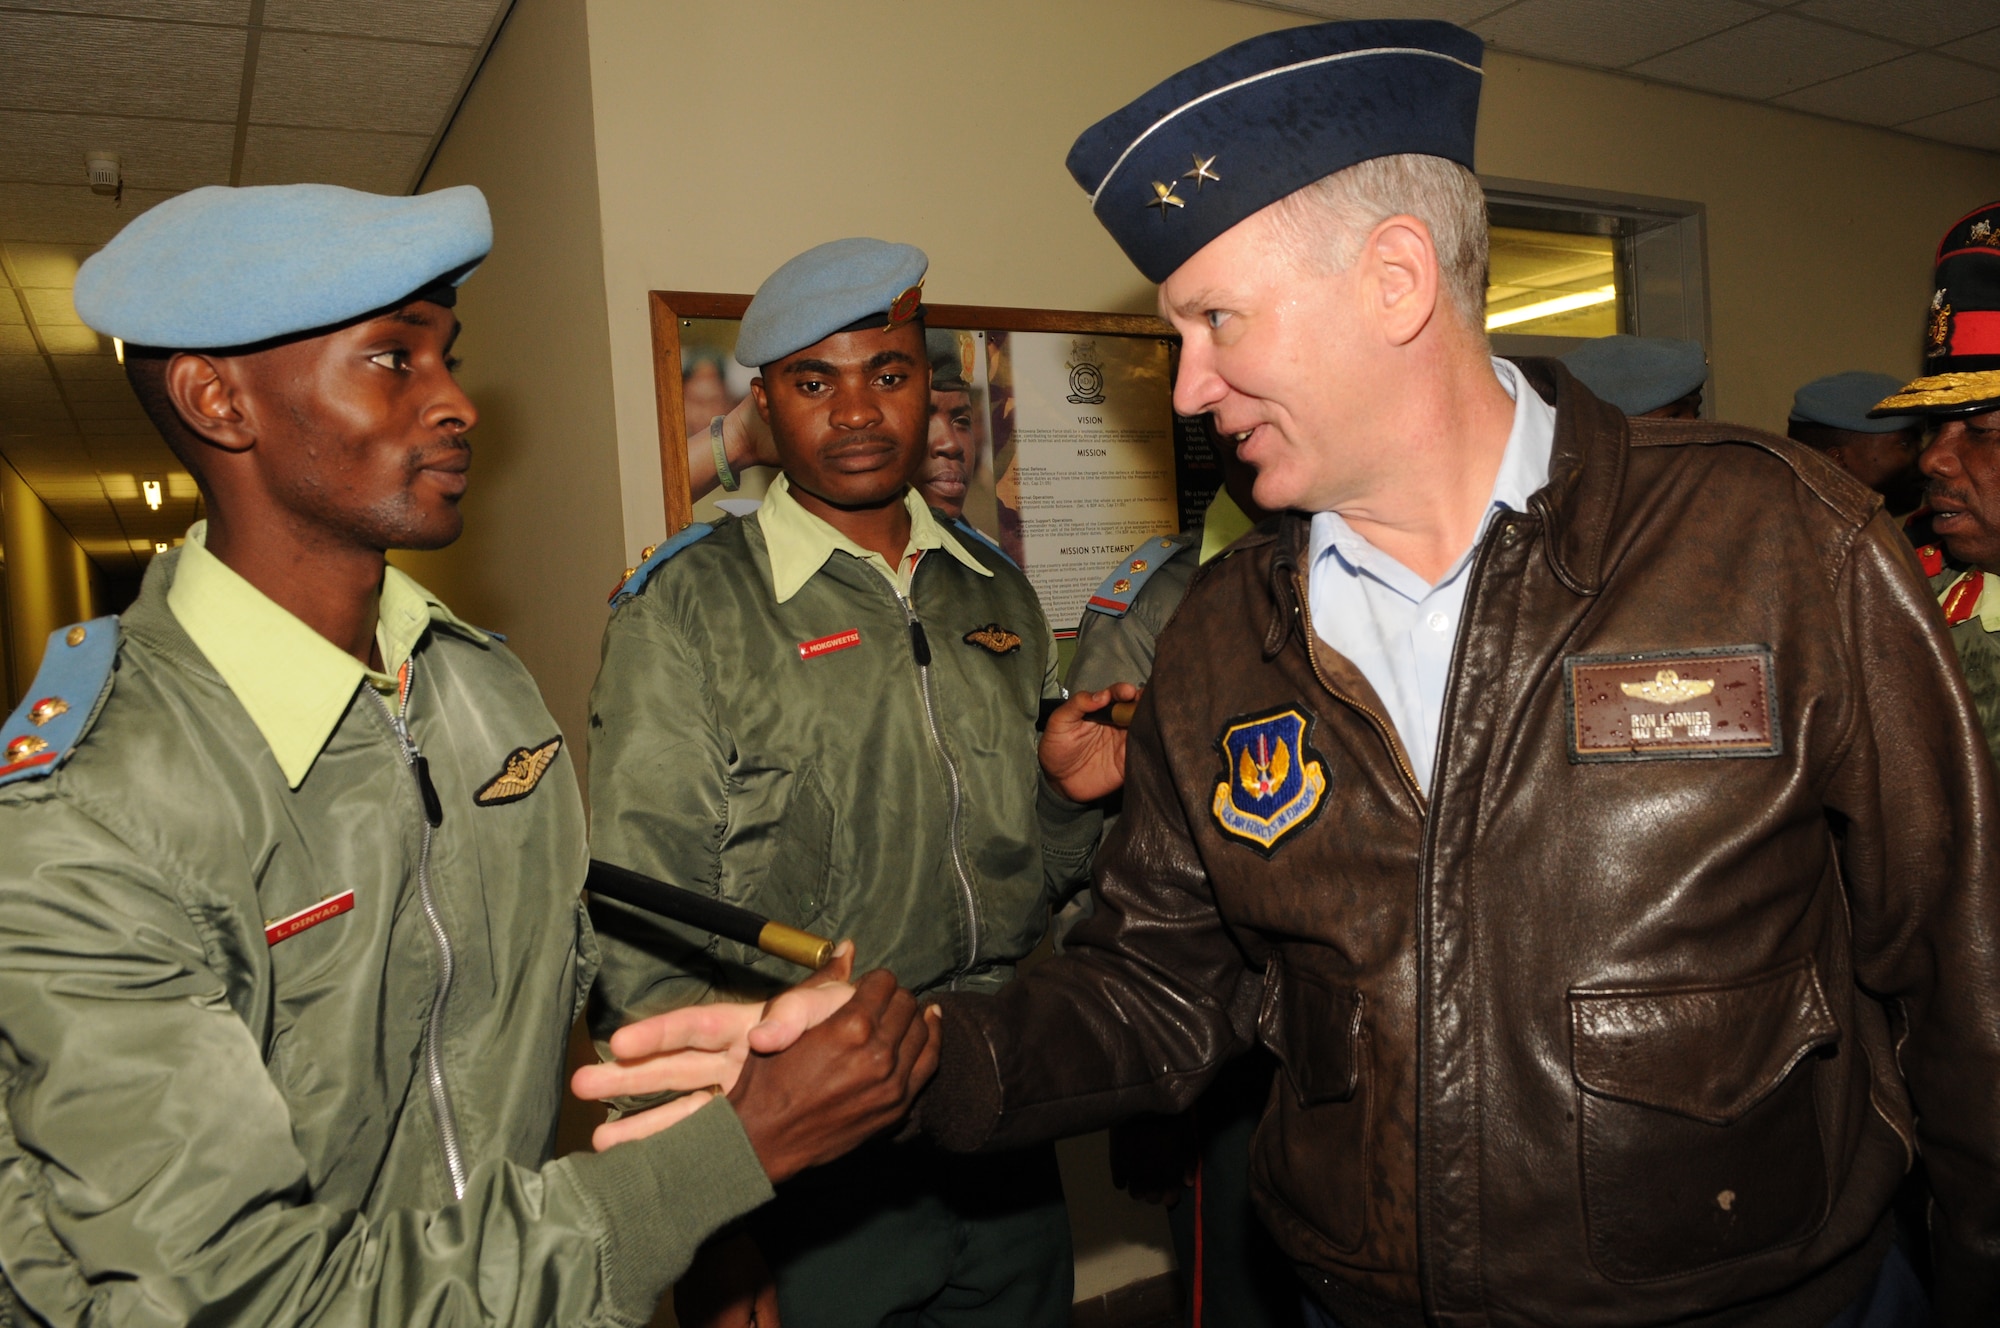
[1870,202,2000,760]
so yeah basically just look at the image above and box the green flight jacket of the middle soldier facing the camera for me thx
[590,518,1096,1038]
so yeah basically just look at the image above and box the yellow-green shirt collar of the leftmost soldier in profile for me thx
[166,522,486,788]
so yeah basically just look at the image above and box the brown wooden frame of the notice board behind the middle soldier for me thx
[648,290,1180,534]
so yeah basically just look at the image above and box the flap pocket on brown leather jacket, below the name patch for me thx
[1570,960,1840,1282]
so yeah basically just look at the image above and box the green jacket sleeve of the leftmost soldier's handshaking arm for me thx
[0,800,770,1326]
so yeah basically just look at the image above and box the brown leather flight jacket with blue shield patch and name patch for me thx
[918,360,2000,1328]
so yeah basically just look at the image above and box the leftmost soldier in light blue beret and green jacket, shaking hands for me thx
[0,186,928,1326]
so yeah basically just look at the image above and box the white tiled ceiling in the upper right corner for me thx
[1248,0,2000,152]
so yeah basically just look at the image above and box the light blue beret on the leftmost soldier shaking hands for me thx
[76,184,494,350]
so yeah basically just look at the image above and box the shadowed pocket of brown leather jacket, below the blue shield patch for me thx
[1250,960,1378,1254]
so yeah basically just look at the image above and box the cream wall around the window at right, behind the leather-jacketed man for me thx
[1478,54,2000,432]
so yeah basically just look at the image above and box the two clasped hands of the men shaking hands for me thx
[570,942,942,1184]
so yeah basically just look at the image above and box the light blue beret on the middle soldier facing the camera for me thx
[736,238,930,368]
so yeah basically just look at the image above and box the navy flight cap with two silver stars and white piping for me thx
[1068,20,1484,282]
